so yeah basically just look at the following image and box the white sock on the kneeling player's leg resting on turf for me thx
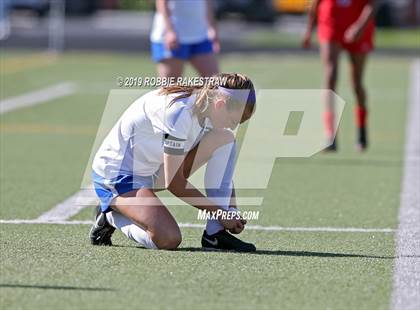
[106,211,157,249]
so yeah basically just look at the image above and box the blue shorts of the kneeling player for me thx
[92,171,156,212]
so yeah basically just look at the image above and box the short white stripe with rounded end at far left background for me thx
[0,82,77,114]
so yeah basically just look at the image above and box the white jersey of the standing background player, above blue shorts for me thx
[150,0,208,44]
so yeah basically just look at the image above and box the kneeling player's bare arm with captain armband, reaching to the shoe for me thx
[163,136,246,230]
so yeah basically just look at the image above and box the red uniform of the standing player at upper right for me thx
[318,0,375,53]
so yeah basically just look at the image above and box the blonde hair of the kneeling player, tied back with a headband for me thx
[160,73,255,114]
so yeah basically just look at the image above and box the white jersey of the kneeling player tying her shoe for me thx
[92,90,212,180]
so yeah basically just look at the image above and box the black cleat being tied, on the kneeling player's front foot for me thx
[201,230,256,252]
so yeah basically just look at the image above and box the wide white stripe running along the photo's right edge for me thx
[391,59,420,309]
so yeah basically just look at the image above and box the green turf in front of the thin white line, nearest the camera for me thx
[0,225,393,309]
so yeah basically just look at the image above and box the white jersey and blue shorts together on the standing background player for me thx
[150,0,213,62]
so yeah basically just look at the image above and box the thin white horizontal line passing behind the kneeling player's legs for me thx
[0,219,395,233]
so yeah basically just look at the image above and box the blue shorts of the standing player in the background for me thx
[151,39,213,62]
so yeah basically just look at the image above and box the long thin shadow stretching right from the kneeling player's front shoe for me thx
[175,247,396,259]
